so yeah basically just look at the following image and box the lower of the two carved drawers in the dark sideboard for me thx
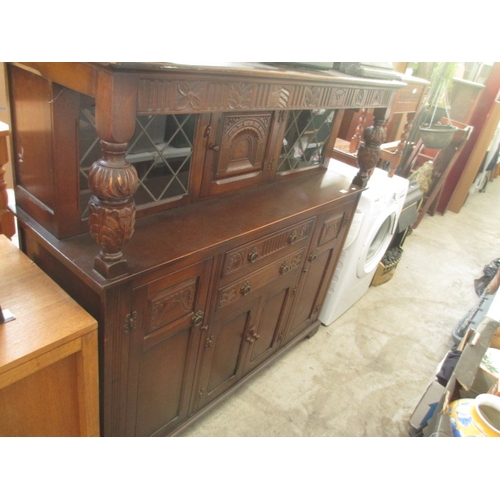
[216,246,307,309]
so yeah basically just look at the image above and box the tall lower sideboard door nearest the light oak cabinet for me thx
[127,260,211,436]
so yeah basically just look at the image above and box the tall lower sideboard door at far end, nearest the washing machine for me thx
[285,199,355,342]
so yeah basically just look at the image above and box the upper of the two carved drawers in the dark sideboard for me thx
[222,217,315,279]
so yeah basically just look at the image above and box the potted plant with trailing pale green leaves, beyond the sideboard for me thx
[419,63,458,149]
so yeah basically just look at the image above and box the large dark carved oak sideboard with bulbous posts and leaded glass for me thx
[8,63,404,436]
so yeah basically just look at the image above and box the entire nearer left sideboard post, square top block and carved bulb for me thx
[89,72,138,278]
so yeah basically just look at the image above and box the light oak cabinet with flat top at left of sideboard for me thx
[0,235,99,436]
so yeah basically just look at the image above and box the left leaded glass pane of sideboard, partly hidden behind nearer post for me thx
[79,106,196,220]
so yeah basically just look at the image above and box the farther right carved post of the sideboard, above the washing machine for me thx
[352,108,386,187]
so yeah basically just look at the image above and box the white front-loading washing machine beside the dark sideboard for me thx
[319,160,409,325]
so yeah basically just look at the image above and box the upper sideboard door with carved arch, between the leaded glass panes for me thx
[201,111,286,197]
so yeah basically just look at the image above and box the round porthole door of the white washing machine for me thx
[356,207,397,278]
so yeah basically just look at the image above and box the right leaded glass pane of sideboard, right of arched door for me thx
[278,109,335,172]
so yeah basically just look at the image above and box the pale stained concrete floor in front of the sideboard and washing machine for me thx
[183,174,500,437]
